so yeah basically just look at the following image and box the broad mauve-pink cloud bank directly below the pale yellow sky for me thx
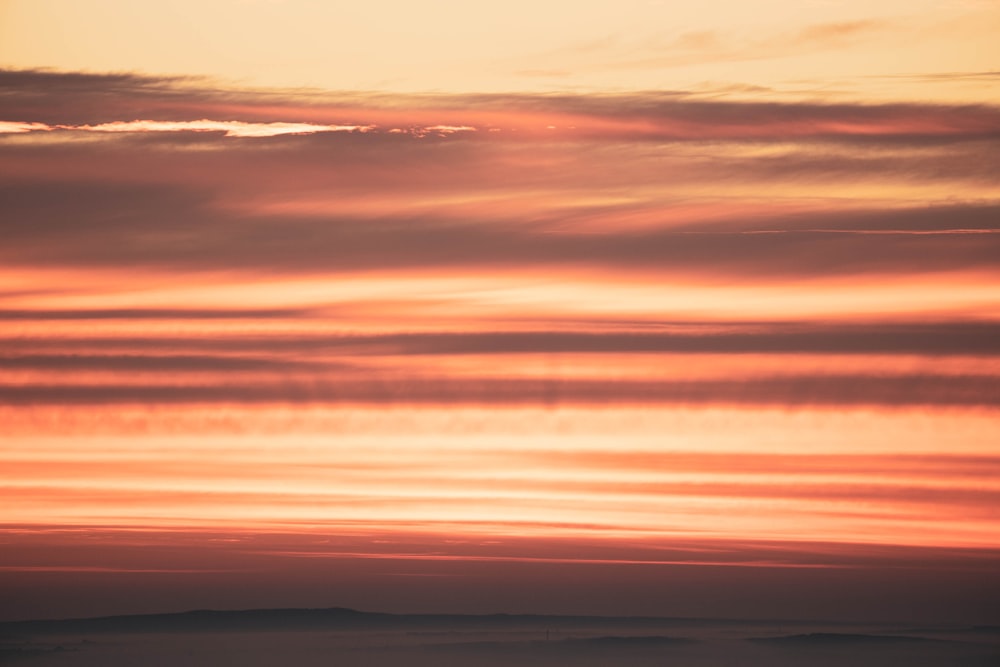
[0,68,1000,280]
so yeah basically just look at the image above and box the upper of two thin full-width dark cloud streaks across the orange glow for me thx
[0,321,1000,363]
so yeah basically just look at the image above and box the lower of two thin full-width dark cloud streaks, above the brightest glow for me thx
[0,374,1000,407]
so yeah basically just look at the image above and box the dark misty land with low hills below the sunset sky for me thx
[0,607,1000,667]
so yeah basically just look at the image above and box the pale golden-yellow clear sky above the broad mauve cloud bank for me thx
[0,0,1000,101]
